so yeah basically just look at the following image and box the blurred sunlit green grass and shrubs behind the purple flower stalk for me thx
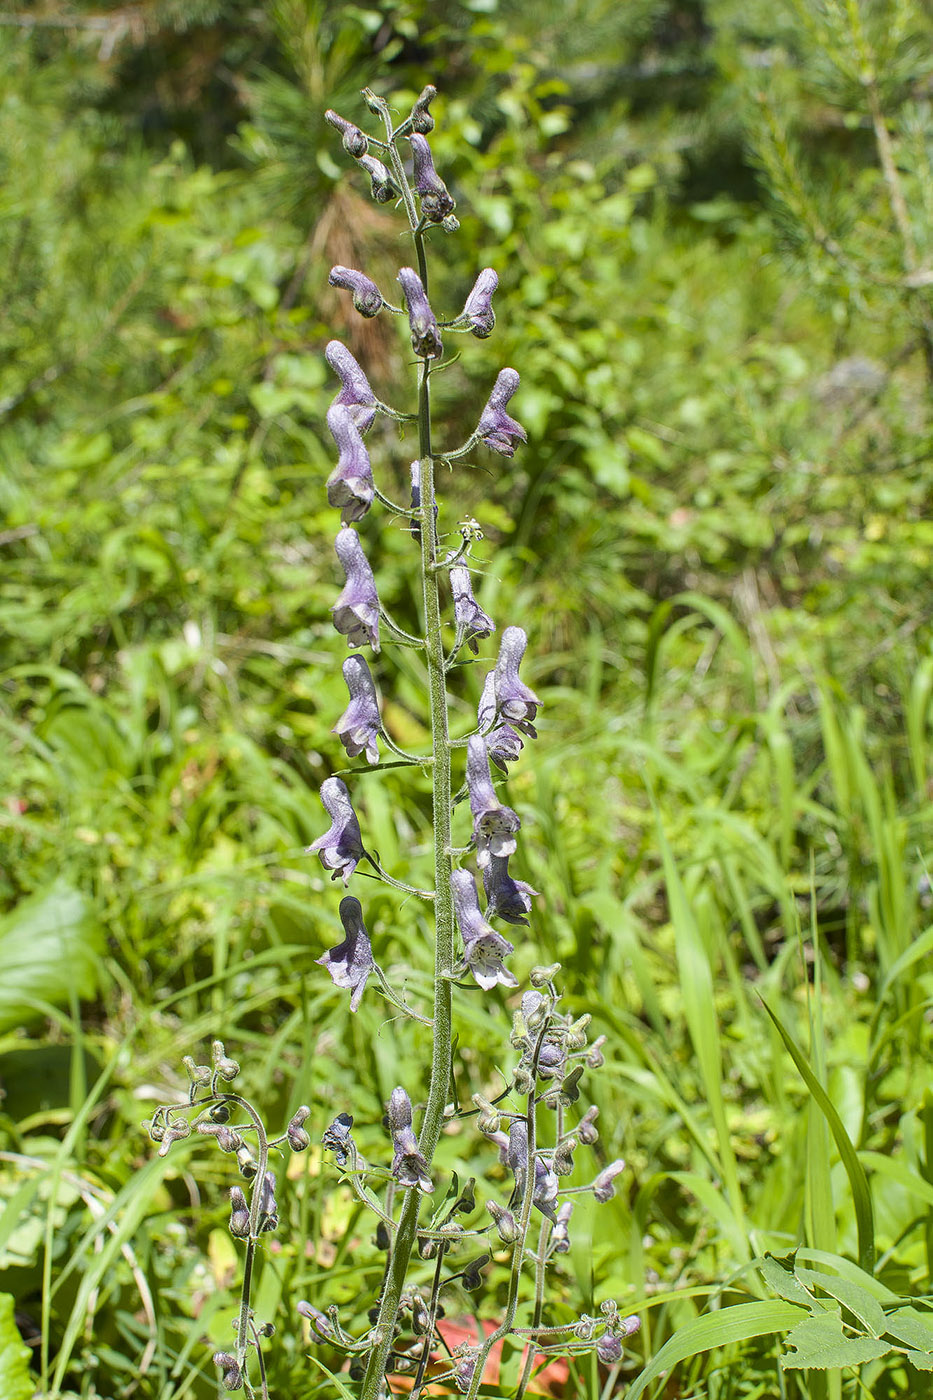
[0,0,933,1400]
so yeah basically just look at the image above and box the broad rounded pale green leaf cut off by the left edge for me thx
[0,879,104,1030]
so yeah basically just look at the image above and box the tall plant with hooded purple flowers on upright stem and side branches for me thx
[150,87,637,1400]
